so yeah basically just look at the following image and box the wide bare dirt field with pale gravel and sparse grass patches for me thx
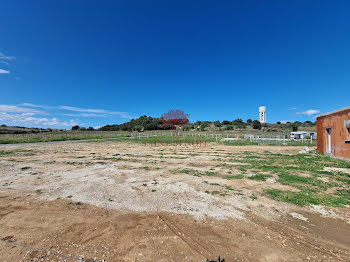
[0,141,350,262]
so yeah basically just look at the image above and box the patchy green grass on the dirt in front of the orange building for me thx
[216,151,350,207]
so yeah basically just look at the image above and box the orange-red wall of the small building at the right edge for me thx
[316,109,350,159]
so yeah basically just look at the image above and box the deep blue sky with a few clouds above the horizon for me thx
[0,0,350,128]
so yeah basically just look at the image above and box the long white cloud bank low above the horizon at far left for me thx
[0,112,78,127]
